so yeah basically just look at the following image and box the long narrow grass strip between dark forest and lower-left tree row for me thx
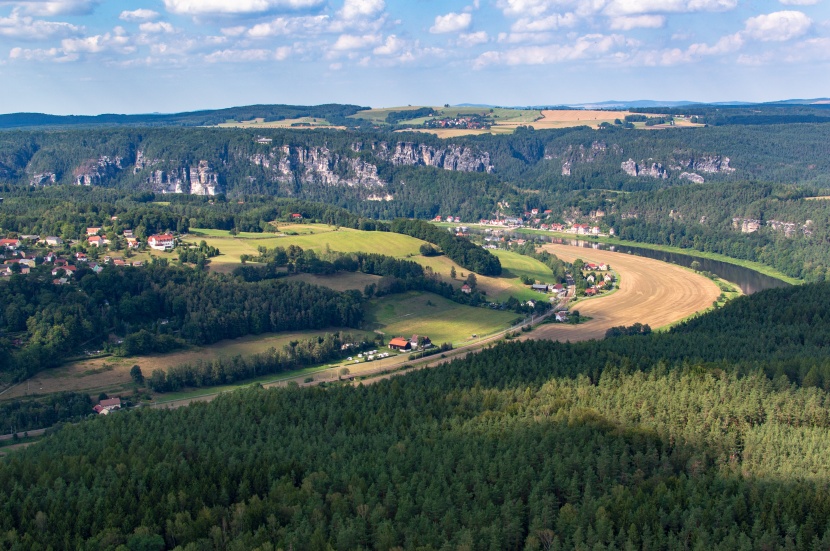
[0,328,374,400]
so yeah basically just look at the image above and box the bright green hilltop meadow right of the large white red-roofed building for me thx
[185,224,423,271]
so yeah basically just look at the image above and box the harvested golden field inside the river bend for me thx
[527,245,721,341]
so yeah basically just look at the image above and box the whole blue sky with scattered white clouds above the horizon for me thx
[0,0,830,114]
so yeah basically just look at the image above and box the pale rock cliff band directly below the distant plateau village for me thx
[372,142,495,174]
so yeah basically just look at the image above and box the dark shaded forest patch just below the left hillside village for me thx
[0,262,363,380]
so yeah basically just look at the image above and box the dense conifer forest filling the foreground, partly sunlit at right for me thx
[0,284,830,550]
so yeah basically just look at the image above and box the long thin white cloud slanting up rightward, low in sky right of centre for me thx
[474,34,635,69]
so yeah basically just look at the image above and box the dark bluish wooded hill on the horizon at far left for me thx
[0,104,367,129]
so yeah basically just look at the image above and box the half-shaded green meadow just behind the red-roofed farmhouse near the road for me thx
[367,291,517,345]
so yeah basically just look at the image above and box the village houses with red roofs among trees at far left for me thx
[0,227,176,285]
